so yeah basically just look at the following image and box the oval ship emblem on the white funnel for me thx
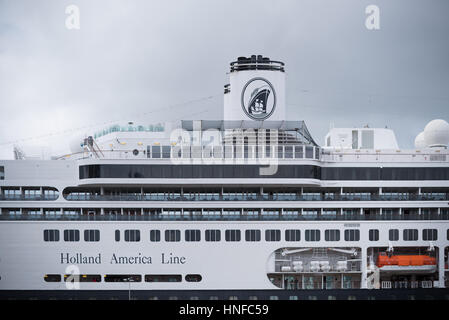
[242,78,276,120]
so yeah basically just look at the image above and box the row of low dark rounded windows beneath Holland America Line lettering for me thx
[44,274,203,282]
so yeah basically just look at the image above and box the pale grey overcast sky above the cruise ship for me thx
[0,0,449,159]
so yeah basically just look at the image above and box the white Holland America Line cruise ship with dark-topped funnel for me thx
[0,55,449,300]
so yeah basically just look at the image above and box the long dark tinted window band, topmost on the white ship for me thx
[79,164,449,181]
